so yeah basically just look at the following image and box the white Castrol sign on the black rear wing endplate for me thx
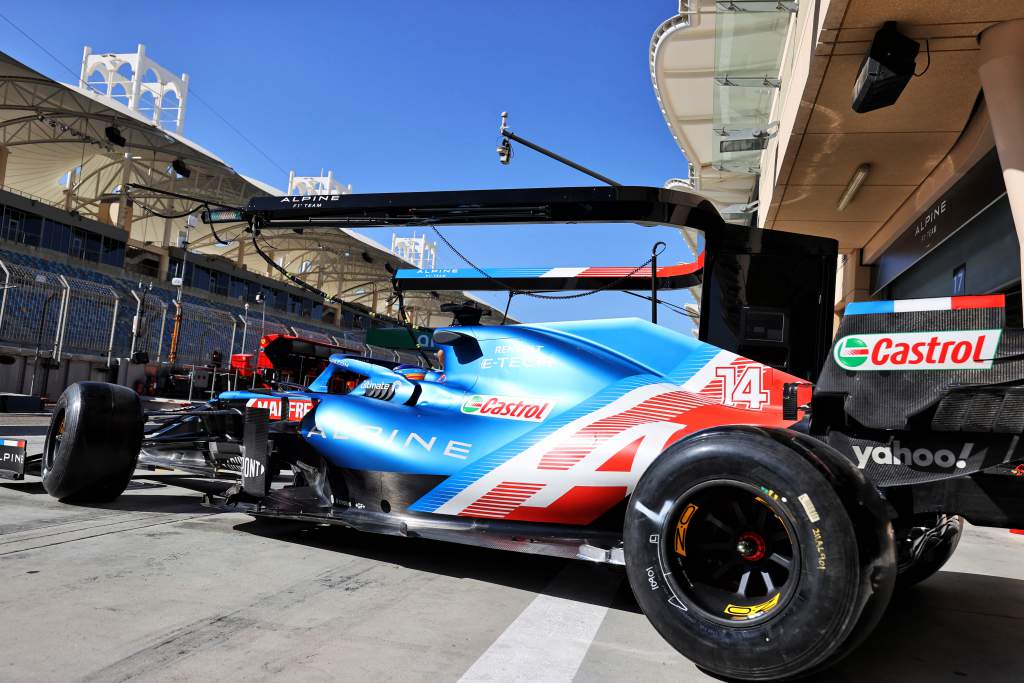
[833,330,1002,372]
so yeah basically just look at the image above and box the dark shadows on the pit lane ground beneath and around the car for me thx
[0,473,1024,683]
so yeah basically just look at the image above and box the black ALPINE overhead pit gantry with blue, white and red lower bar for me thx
[209,186,838,379]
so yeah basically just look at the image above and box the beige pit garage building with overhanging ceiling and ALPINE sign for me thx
[649,0,1024,326]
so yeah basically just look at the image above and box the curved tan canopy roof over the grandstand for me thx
[0,52,509,327]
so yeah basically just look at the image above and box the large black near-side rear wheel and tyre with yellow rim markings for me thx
[625,427,895,680]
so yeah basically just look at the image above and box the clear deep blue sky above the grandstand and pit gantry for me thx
[0,0,692,331]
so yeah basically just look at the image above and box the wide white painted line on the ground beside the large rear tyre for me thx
[459,562,623,683]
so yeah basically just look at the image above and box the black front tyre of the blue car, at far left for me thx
[42,382,145,503]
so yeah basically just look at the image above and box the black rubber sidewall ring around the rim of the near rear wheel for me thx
[625,430,860,676]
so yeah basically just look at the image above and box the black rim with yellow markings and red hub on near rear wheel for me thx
[662,480,800,626]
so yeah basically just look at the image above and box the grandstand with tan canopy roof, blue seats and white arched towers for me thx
[0,45,507,398]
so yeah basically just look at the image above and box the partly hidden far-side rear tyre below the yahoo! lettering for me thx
[896,515,964,591]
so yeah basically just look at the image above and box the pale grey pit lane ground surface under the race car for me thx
[0,416,1024,683]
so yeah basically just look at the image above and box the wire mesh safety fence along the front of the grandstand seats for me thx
[0,260,423,376]
